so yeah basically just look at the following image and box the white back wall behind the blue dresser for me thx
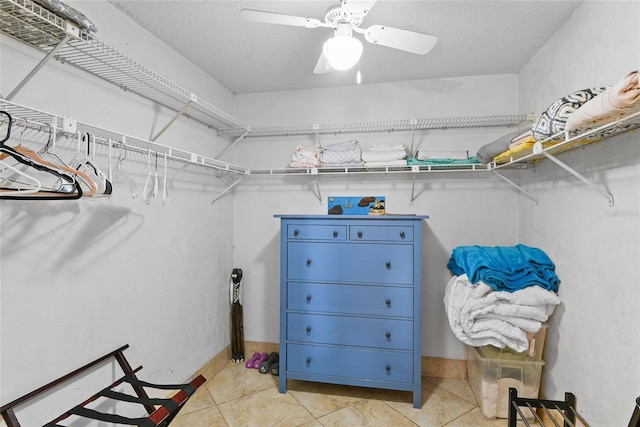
[234,75,518,359]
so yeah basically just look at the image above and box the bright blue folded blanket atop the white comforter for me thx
[447,245,560,292]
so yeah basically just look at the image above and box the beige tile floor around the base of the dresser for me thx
[171,362,507,427]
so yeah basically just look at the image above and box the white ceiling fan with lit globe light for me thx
[240,0,438,74]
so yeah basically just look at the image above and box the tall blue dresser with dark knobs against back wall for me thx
[276,215,427,408]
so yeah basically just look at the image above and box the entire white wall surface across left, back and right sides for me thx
[0,1,640,426]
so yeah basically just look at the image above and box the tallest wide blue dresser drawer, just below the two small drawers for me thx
[287,241,414,285]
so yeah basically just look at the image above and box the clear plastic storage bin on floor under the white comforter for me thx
[467,346,544,418]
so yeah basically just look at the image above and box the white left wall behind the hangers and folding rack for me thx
[0,1,238,425]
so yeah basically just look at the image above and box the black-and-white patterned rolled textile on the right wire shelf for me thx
[531,87,607,141]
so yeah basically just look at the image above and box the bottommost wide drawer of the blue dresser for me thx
[286,344,413,383]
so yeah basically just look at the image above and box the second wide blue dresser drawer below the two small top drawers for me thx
[287,282,413,317]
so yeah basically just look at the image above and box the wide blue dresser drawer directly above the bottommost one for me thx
[287,313,413,350]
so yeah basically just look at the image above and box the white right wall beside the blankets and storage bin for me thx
[519,1,640,426]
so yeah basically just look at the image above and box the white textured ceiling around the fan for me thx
[110,0,580,93]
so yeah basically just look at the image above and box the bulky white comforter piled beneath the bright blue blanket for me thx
[444,274,560,352]
